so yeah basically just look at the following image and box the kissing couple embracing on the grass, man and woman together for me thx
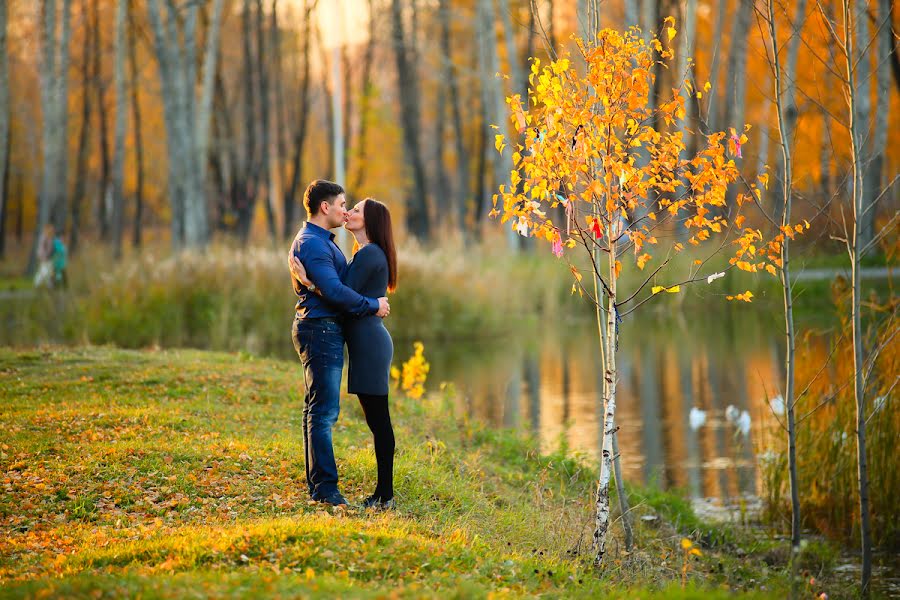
[288,179,397,509]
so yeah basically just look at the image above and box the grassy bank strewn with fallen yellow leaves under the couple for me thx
[0,348,850,598]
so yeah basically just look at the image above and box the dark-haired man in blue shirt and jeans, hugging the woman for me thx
[289,180,390,505]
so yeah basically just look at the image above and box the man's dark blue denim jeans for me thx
[291,317,344,500]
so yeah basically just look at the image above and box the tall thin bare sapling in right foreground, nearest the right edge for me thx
[842,0,872,596]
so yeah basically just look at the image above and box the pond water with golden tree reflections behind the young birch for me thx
[418,312,783,501]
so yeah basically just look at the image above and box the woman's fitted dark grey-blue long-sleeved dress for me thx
[344,243,394,396]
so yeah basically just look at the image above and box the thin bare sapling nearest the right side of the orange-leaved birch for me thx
[767,0,806,568]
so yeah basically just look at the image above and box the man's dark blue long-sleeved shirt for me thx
[291,222,378,319]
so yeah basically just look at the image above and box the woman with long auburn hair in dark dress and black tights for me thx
[294,198,397,508]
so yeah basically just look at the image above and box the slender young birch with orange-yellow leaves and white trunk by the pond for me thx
[493,24,796,565]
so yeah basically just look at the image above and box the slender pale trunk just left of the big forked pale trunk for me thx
[112,0,128,260]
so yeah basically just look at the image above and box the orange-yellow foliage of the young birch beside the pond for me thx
[494,25,809,301]
